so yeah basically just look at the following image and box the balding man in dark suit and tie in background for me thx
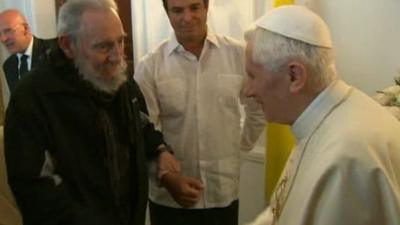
[0,9,56,92]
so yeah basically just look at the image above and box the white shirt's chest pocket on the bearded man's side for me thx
[157,78,186,116]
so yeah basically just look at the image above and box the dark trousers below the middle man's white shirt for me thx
[149,200,239,225]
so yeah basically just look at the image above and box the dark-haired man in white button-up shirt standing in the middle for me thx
[134,0,265,225]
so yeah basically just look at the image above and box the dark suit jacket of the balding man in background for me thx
[3,37,57,92]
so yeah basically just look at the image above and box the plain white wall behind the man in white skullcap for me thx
[307,0,400,95]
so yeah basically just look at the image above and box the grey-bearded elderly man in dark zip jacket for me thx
[5,0,197,225]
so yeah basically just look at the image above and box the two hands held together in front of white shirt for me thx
[158,151,204,208]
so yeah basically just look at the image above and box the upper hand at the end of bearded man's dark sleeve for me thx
[157,151,181,179]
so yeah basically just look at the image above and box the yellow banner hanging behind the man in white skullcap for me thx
[265,0,295,202]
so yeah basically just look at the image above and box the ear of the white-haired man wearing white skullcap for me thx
[288,61,308,93]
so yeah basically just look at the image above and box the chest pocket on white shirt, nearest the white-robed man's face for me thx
[217,74,244,107]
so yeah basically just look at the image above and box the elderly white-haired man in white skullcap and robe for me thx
[246,6,400,225]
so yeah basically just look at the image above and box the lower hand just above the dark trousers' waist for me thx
[160,173,204,208]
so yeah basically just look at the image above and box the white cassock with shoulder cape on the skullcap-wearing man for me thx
[251,81,400,225]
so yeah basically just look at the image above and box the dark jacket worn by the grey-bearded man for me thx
[4,49,163,225]
